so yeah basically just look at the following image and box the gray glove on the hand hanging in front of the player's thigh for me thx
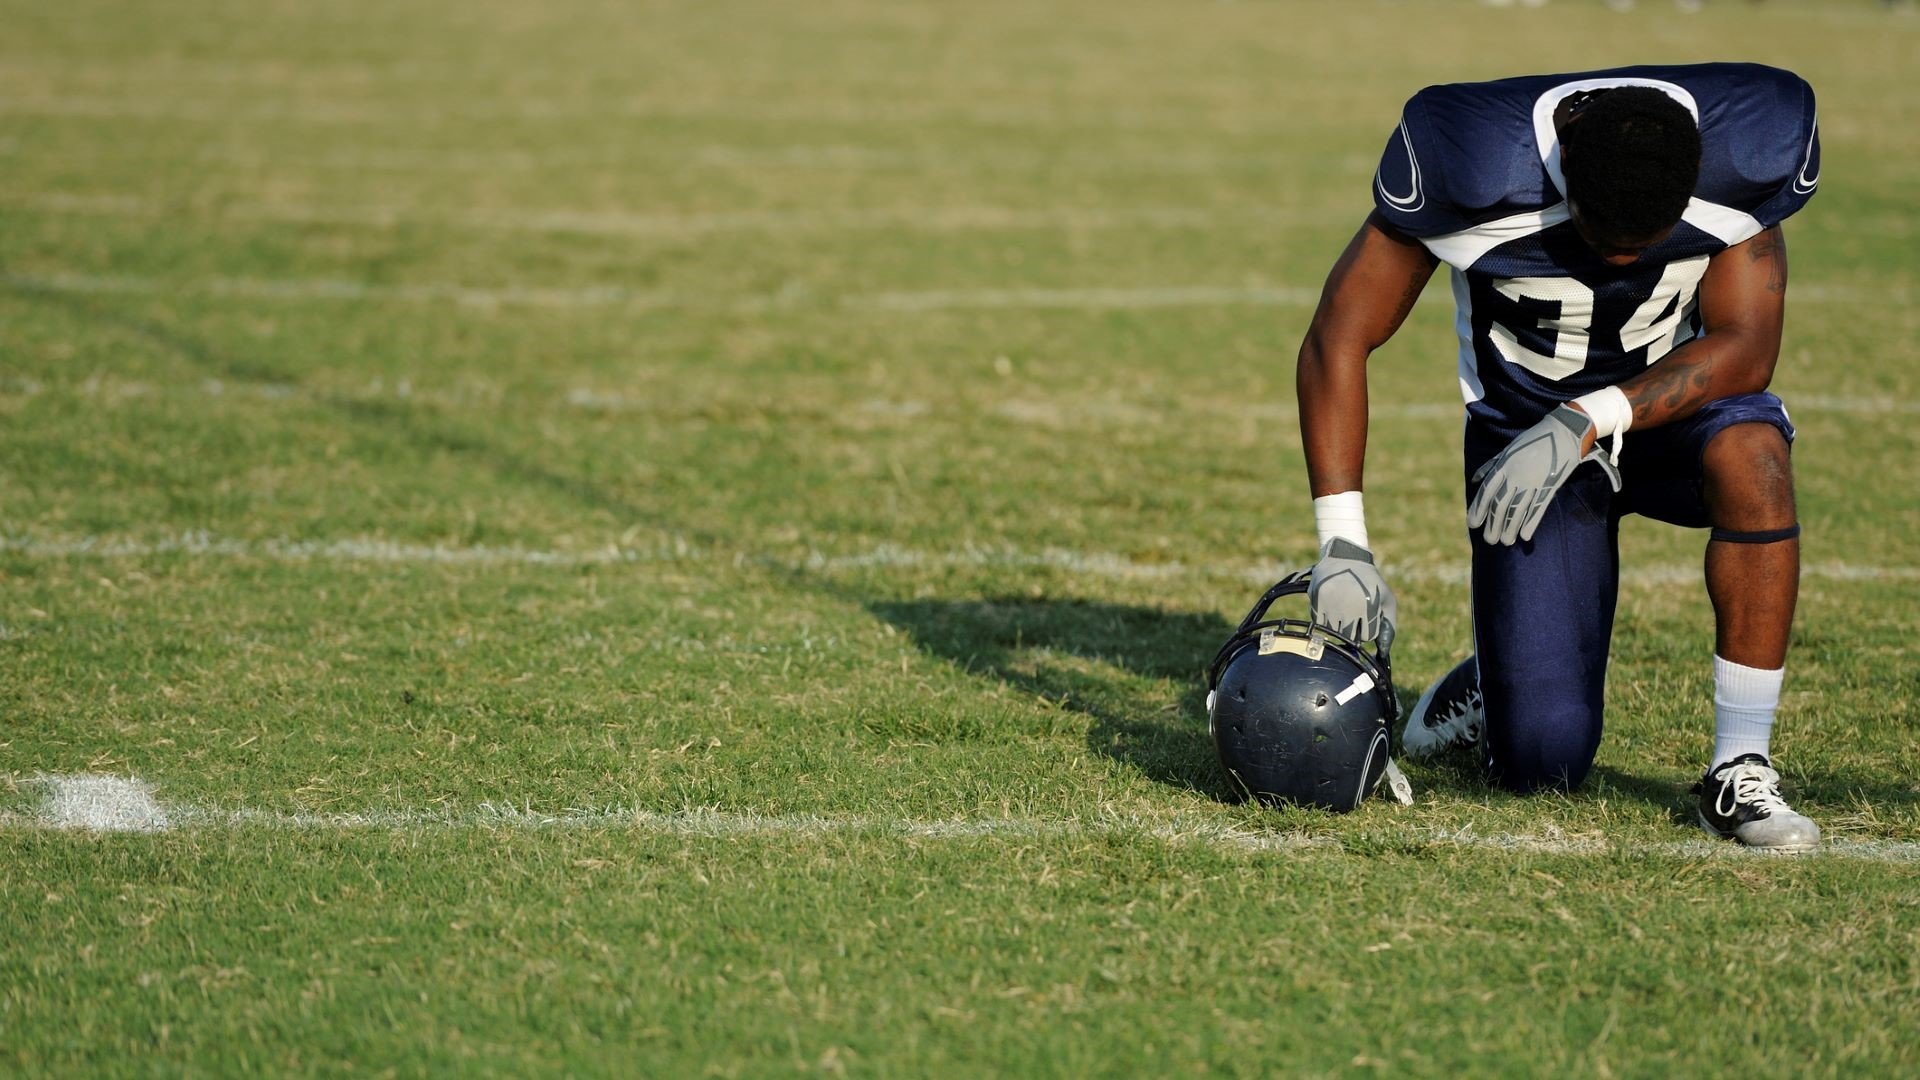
[1467,405,1620,544]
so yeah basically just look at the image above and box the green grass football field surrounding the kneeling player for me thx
[0,0,1920,1076]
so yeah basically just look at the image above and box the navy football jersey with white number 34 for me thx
[1373,63,1820,434]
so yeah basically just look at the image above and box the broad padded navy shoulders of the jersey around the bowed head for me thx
[1373,63,1820,238]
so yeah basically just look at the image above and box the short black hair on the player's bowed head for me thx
[1559,86,1699,238]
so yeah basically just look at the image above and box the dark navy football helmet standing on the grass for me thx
[1206,571,1411,813]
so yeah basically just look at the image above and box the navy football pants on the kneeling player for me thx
[1467,394,1793,792]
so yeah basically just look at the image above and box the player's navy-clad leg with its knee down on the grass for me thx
[1473,465,1619,792]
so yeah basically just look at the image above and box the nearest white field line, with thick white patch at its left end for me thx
[11,774,1920,863]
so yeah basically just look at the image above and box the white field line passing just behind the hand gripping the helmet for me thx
[0,532,1920,586]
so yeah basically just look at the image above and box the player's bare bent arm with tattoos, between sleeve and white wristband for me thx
[1588,225,1788,446]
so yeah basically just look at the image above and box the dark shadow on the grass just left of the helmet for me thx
[868,598,1233,799]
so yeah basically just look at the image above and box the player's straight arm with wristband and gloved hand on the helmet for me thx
[1294,211,1438,648]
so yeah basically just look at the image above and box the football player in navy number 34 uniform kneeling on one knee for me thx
[1298,63,1820,851]
